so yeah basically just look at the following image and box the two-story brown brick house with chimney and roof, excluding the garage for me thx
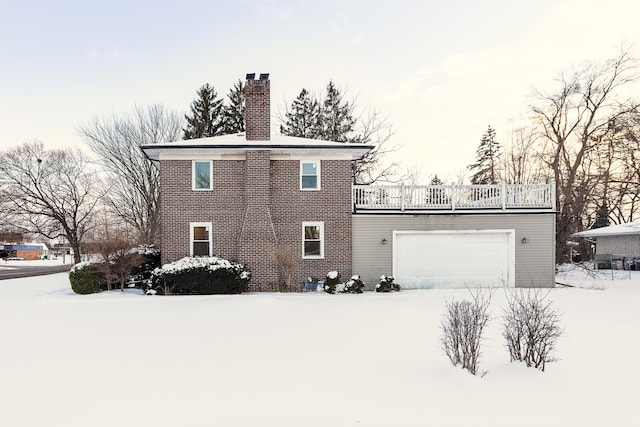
[143,75,373,288]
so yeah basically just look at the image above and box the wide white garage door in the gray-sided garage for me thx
[393,230,515,288]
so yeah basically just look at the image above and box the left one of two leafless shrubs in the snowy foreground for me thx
[440,290,493,375]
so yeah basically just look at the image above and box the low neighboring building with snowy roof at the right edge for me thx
[574,221,640,268]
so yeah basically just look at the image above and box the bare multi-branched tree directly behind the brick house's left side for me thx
[79,105,183,244]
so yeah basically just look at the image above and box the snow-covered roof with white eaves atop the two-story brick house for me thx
[142,132,374,160]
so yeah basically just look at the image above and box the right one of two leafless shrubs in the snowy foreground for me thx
[502,289,562,372]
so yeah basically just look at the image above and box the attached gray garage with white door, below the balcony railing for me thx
[351,211,555,289]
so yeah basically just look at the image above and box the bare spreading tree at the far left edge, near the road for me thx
[0,142,98,263]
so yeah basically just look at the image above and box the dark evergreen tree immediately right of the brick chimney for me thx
[280,89,320,139]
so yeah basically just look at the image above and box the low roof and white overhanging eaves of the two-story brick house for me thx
[141,133,374,161]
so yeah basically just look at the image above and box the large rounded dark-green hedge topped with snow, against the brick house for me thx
[148,257,251,295]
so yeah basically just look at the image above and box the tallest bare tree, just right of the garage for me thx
[532,50,638,262]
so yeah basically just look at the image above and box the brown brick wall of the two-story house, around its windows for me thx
[160,155,352,288]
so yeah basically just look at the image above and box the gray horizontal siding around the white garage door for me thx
[352,214,555,288]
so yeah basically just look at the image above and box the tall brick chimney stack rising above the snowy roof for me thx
[244,74,271,141]
